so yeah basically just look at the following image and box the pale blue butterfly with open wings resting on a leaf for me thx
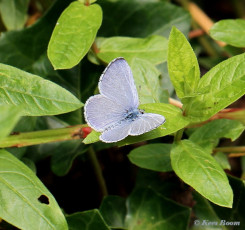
[84,58,165,143]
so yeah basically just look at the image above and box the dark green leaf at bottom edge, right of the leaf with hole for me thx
[66,209,110,230]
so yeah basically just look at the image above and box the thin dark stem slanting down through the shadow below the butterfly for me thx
[88,145,108,197]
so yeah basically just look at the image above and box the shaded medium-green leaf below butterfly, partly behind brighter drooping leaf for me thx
[128,144,172,172]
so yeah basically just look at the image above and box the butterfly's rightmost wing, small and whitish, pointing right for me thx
[129,113,165,136]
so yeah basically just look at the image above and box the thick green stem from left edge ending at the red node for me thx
[0,125,87,148]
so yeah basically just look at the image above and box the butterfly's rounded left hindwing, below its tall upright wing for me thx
[84,94,124,132]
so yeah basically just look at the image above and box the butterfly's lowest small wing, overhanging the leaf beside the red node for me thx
[100,120,131,143]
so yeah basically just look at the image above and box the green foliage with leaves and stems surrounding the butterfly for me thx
[0,0,245,230]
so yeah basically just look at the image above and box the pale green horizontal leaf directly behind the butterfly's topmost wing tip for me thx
[96,35,167,65]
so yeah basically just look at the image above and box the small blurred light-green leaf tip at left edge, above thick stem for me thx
[0,105,22,140]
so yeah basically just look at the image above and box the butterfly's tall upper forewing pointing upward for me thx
[99,58,139,110]
